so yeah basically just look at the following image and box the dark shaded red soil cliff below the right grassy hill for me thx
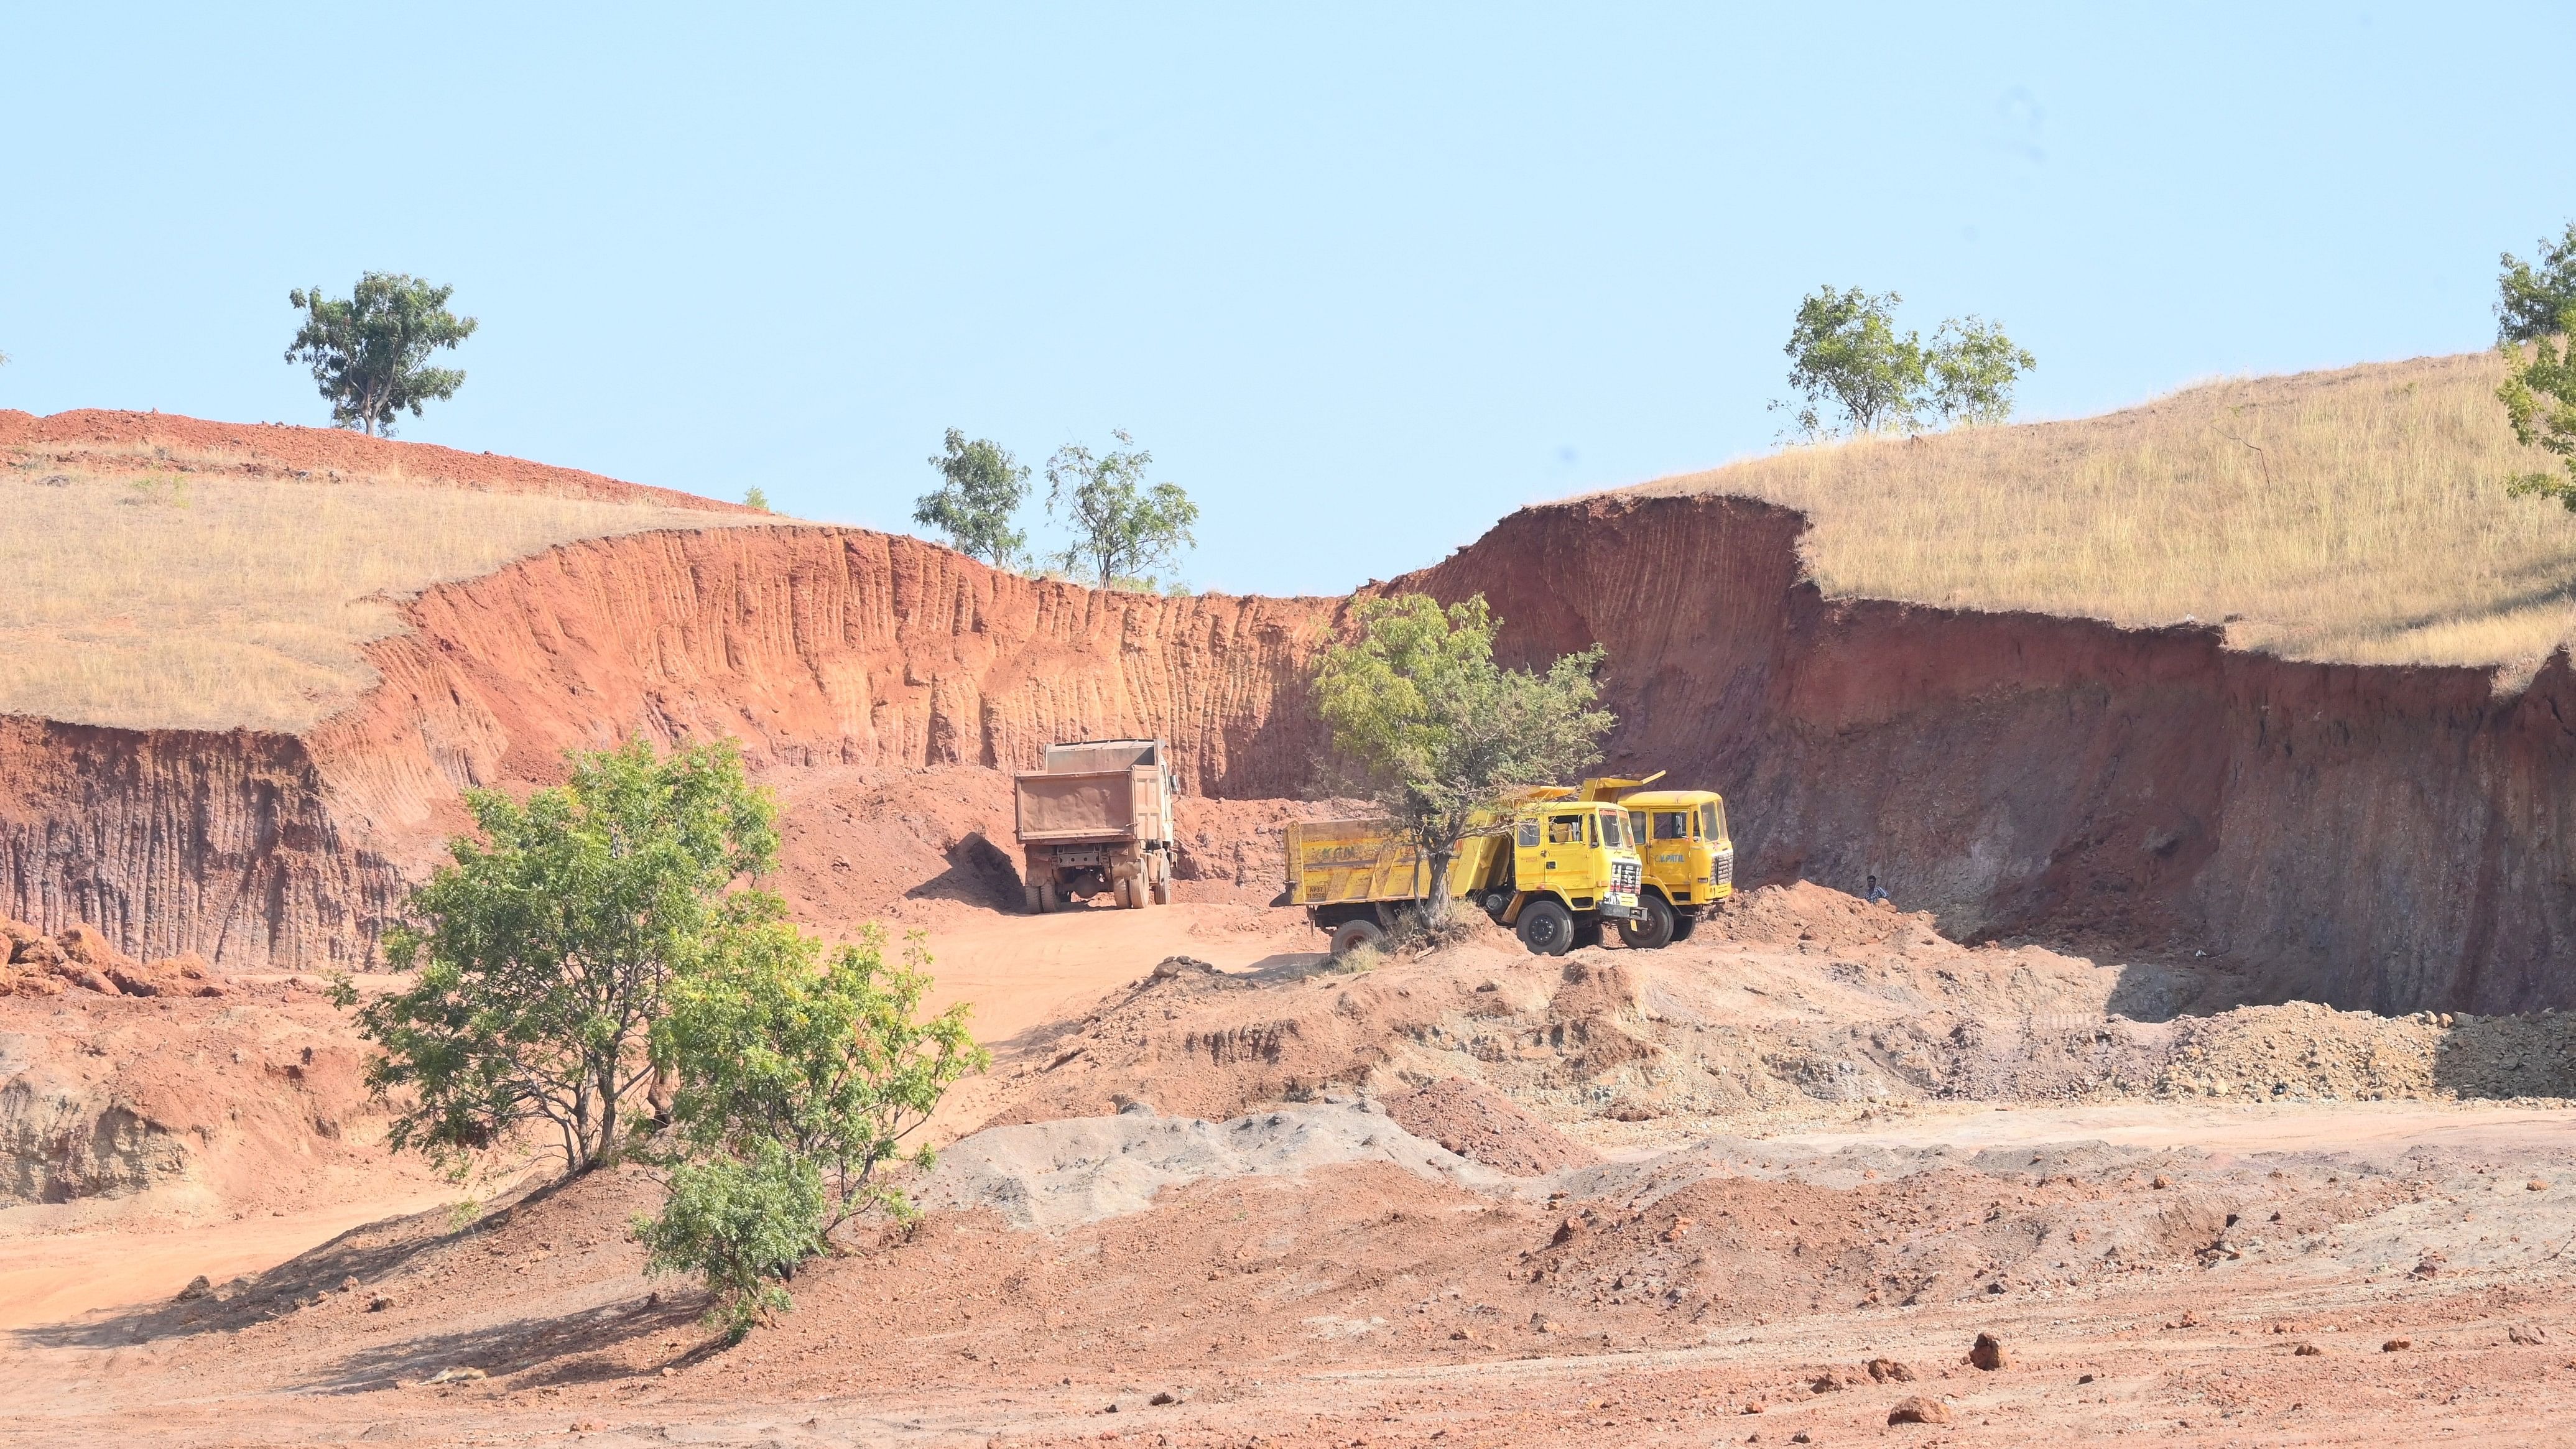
[1389,497,2576,1011]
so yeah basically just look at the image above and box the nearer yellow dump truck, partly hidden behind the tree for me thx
[1288,790,1644,955]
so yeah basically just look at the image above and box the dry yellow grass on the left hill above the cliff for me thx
[0,448,758,731]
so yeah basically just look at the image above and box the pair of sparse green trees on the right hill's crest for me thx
[1772,285,2037,438]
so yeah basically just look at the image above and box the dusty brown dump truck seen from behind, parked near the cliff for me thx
[1012,739,1172,911]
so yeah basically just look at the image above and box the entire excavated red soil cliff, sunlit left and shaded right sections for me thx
[0,476,2576,1011]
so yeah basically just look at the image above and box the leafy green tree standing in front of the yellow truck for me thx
[1313,595,1615,924]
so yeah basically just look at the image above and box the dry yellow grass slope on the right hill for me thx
[1644,353,2576,669]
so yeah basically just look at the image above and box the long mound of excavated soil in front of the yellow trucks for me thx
[992,883,2576,1140]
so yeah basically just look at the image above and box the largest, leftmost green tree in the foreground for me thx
[340,739,781,1176]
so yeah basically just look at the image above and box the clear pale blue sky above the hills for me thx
[0,5,2576,592]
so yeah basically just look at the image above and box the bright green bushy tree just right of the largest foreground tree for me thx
[654,922,992,1233]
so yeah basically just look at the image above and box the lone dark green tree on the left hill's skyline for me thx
[286,273,476,438]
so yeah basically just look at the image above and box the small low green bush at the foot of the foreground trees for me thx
[634,1143,822,1341]
